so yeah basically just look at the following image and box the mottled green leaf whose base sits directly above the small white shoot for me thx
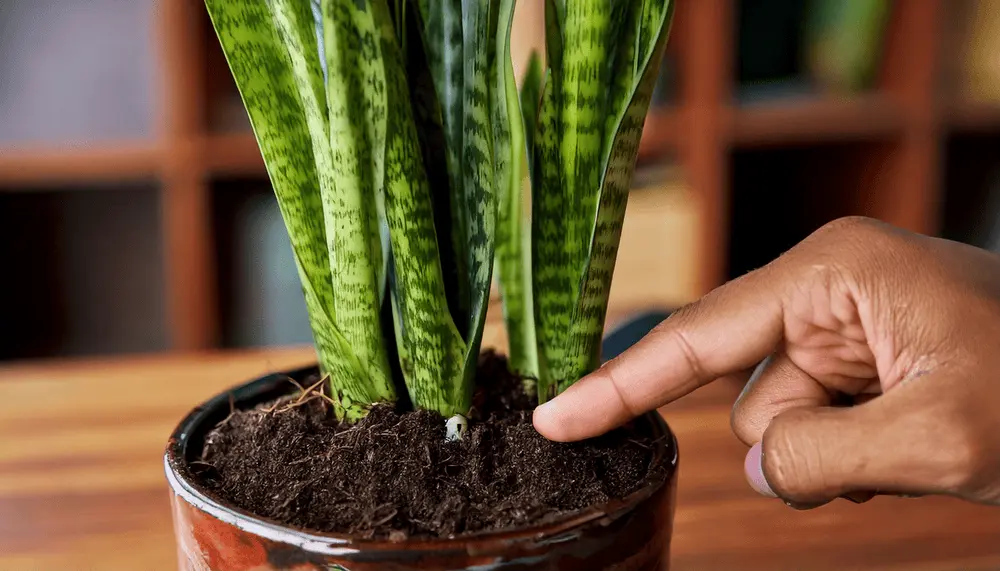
[368,0,472,417]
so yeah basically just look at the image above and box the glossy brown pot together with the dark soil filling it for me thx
[167,353,677,571]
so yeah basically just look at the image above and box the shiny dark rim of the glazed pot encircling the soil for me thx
[163,365,679,556]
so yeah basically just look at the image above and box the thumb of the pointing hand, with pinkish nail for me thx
[746,394,949,507]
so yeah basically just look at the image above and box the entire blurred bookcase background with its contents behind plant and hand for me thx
[0,0,1000,360]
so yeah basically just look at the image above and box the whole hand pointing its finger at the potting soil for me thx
[534,218,1000,508]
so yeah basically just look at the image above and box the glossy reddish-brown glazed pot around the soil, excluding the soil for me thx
[164,368,677,571]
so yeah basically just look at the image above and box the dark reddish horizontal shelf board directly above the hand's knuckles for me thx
[731,95,905,147]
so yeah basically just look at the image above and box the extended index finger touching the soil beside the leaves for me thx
[534,267,784,442]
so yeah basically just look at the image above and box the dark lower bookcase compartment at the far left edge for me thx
[0,184,167,359]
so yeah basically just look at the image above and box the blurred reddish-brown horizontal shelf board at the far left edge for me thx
[0,141,163,190]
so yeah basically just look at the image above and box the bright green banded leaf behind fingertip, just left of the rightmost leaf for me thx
[532,0,616,401]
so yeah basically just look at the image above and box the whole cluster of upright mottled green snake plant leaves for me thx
[206,0,672,428]
